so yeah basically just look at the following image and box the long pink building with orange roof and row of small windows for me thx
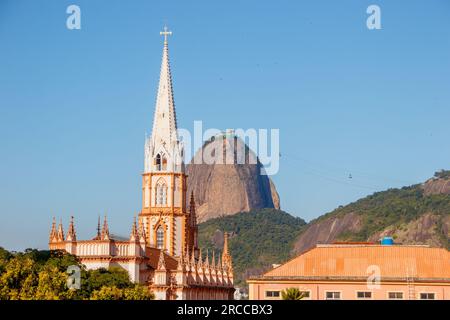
[248,243,450,300]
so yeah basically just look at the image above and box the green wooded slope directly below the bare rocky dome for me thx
[199,209,306,286]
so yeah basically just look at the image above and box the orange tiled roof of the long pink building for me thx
[262,244,450,280]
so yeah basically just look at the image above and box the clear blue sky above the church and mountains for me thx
[0,0,450,250]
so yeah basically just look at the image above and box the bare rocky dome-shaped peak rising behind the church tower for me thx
[186,134,280,222]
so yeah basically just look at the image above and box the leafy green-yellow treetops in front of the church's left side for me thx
[0,248,154,300]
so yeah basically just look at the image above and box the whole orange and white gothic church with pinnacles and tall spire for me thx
[49,28,234,300]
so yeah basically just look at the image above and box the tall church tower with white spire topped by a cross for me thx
[139,27,197,257]
